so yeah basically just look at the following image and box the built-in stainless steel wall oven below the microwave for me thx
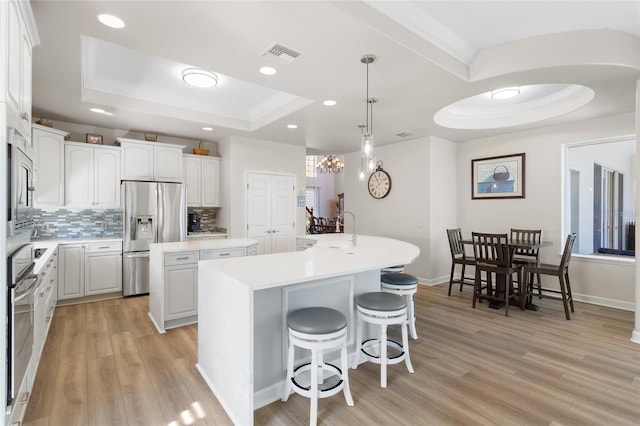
[6,243,40,407]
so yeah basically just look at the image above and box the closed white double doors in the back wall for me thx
[247,173,295,254]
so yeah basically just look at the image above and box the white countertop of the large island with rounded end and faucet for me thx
[199,234,420,290]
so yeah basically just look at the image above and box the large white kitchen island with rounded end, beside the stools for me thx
[197,234,420,425]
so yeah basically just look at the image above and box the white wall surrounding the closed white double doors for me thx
[218,136,305,238]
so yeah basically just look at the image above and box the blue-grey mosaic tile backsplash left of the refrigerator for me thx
[32,209,122,240]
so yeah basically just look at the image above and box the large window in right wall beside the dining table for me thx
[564,139,636,256]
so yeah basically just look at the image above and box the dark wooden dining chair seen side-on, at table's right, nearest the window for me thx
[524,234,576,319]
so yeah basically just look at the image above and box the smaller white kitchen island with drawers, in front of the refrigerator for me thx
[149,238,258,333]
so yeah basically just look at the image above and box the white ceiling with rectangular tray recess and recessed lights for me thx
[32,0,640,153]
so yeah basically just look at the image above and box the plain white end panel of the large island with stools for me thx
[197,268,254,425]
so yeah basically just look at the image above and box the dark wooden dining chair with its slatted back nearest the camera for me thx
[471,232,525,316]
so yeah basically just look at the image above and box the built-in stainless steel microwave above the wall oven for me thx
[7,128,34,243]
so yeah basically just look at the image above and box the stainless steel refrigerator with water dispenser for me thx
[121,181,187,297]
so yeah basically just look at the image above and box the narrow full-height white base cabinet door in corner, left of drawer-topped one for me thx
[58,244,84,300]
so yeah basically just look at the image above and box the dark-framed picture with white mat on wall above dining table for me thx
[471,152,525,200]
